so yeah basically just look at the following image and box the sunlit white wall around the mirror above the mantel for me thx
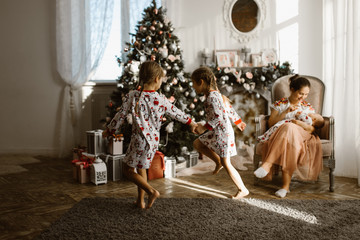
[165,0,322,78]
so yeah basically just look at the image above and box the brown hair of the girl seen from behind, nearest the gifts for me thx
[135,61,165,114]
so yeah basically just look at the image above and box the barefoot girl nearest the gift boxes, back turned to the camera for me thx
[104,61,197,208]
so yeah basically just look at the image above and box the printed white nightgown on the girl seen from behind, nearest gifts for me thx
[108,90,191,169]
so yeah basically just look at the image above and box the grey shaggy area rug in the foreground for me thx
[38,198,360,240]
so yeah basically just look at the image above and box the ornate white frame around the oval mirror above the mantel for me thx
[223,0,266,43]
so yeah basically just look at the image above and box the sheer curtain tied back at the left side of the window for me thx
[56,0,113,157]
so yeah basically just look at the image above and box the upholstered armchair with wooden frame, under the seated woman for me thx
[254,75,335,192]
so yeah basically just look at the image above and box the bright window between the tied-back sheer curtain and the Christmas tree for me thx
[91,0,161,82]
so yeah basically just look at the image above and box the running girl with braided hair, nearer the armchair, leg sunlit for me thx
[191,67,249,198]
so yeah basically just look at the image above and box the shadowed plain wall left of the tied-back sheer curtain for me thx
[0,0,62,155]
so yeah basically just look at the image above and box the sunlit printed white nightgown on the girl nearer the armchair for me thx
[199,91,241,157]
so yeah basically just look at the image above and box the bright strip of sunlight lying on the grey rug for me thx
[240,198,318,224]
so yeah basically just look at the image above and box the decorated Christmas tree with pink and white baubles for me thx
[107,0,204,157]
